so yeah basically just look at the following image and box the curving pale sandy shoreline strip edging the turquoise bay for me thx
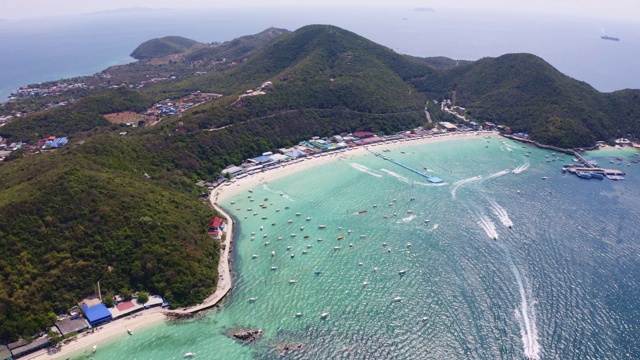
[37,132,490,359]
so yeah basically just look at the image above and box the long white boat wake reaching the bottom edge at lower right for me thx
[511,262,542,360]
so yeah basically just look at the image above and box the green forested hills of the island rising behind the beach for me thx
[0,25,640,340]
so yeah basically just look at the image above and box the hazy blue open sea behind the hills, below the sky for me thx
[0,8,640,100]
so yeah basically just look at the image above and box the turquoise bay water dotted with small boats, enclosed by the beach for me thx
[77,136,640,360]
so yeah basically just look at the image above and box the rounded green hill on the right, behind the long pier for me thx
[413,54,640,147]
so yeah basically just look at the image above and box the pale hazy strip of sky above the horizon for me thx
[0,0,640,21]
